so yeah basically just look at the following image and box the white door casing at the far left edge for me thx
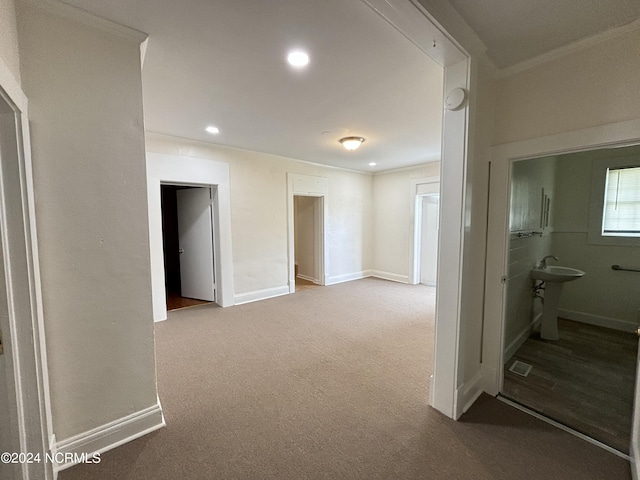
[0,83,53,479]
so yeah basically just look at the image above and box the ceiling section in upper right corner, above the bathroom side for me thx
[449,0,640,68]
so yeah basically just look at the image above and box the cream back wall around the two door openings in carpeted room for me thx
[147,134,373,298]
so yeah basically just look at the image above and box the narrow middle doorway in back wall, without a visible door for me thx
[293,195,324,290]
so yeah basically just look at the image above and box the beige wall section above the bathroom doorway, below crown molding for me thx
[493,29,640,144]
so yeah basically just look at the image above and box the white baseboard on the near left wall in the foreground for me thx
[54,402,165,472]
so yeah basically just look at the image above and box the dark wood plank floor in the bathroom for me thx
[502,319,638,453]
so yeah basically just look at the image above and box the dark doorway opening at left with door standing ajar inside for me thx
[161,185,216,310]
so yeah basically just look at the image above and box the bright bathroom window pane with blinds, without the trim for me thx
[602,167,640,237]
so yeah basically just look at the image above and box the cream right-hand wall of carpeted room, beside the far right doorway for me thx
[373,162,440,283]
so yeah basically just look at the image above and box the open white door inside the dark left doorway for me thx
[176,187,215,302]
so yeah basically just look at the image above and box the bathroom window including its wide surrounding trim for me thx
[589,155,640,246]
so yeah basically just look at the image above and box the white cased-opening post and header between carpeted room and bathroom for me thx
[362,0,472,419]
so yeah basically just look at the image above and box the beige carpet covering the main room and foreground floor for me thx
[59,279,631,480]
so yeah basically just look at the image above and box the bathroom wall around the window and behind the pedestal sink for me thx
[552,147,640,331]
